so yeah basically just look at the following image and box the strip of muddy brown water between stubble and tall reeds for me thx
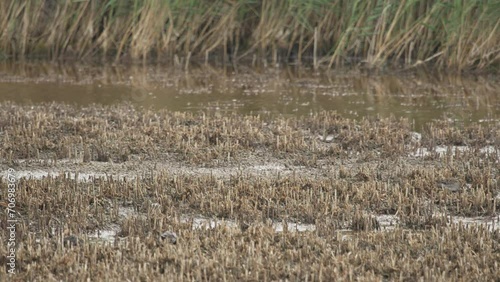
[0,62,500,131]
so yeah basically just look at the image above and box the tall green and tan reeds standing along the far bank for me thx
[0,0,500,70]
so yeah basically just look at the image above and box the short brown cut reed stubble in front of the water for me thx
[0,103,500,281]
